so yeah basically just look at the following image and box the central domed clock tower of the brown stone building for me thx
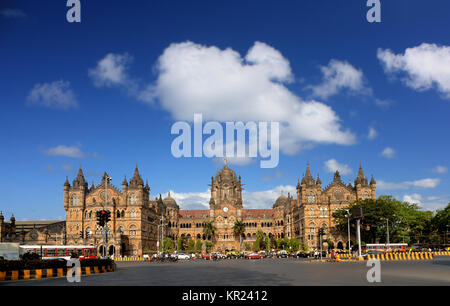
[209,159,243,250]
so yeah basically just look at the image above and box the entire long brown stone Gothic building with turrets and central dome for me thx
[64,164,376,255]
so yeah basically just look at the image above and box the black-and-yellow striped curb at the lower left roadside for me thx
[0,265,115,281]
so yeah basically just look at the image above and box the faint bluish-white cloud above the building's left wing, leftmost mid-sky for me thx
[27,81,78,109]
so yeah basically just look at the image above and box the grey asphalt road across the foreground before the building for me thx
[0,256,450,286]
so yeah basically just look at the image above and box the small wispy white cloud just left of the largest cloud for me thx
[89,53,133,87]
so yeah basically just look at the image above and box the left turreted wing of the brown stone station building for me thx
[64,166,164,256]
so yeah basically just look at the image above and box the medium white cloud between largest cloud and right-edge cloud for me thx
[309,59,372,99]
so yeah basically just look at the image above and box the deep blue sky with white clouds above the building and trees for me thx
[0,0,450,219]
